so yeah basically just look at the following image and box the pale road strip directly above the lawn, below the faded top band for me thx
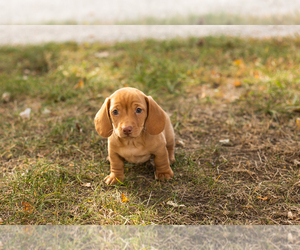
[0,25,300,44]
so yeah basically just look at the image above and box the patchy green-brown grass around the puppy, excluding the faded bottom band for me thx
[0,36,300,225]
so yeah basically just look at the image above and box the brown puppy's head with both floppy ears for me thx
[95,88,165,138]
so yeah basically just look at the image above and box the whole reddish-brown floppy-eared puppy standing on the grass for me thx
[95,88,175,184]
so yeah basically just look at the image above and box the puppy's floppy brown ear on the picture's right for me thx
[145,96,166,135]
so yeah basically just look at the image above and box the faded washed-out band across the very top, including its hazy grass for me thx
[0,0,300,25]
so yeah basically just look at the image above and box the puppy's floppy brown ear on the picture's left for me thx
[95,98,113,138]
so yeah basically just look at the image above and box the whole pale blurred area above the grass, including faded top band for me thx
[0,0,300,44]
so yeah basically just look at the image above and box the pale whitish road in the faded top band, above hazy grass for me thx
[0,0,300,24]
